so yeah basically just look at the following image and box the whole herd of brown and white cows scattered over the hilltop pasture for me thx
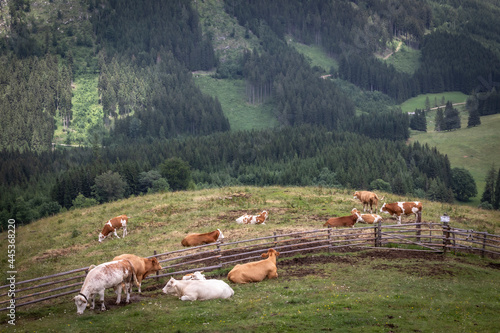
[74,191,422,314]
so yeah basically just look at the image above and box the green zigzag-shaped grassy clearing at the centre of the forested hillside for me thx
[193,73,278,131]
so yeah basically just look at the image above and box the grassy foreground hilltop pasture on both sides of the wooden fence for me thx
[0,187,500,332]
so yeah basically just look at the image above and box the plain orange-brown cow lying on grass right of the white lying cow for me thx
[227,249,280,284]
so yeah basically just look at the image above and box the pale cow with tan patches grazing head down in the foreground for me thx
[73,260,139,314]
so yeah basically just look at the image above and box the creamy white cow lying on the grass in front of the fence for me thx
[162,277,234,301]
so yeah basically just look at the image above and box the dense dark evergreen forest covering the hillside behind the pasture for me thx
[0,0,500,228]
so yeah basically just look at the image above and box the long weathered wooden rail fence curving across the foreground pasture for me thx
[0,222,500,311]
